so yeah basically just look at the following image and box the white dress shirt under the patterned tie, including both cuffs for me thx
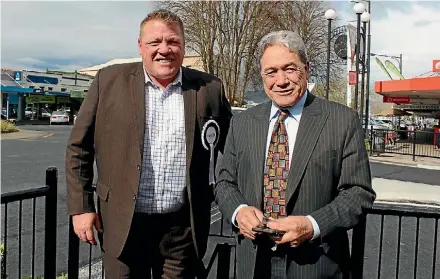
[232,92,321,240]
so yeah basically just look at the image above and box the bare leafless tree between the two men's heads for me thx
[161,1,272,104]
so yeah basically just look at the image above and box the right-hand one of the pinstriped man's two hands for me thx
[267,216,313,247]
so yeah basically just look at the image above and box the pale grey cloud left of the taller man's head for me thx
[1,1,157,70]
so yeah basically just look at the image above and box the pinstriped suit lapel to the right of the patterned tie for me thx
[286,93,328,201]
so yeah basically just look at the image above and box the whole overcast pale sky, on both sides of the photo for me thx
[1,1,440,86]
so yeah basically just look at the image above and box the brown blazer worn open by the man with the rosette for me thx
[66,63,232,258]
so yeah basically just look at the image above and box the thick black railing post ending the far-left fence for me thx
[44,167,58,279]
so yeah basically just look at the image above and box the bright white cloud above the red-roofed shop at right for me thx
[334,1,440,85]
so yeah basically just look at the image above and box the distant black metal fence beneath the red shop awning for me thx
[368,127,440,160]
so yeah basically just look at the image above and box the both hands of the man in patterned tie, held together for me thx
[235,206,313,247]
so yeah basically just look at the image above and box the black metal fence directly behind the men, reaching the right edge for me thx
[68,202,440,279]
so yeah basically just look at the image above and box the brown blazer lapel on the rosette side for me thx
[182,68,197,200]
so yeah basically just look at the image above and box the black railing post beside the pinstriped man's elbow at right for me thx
[351,218,367,279]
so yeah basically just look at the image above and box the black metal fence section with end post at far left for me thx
[1,167,58,279]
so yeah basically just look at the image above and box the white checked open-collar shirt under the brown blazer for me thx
[135,69,186,214]
